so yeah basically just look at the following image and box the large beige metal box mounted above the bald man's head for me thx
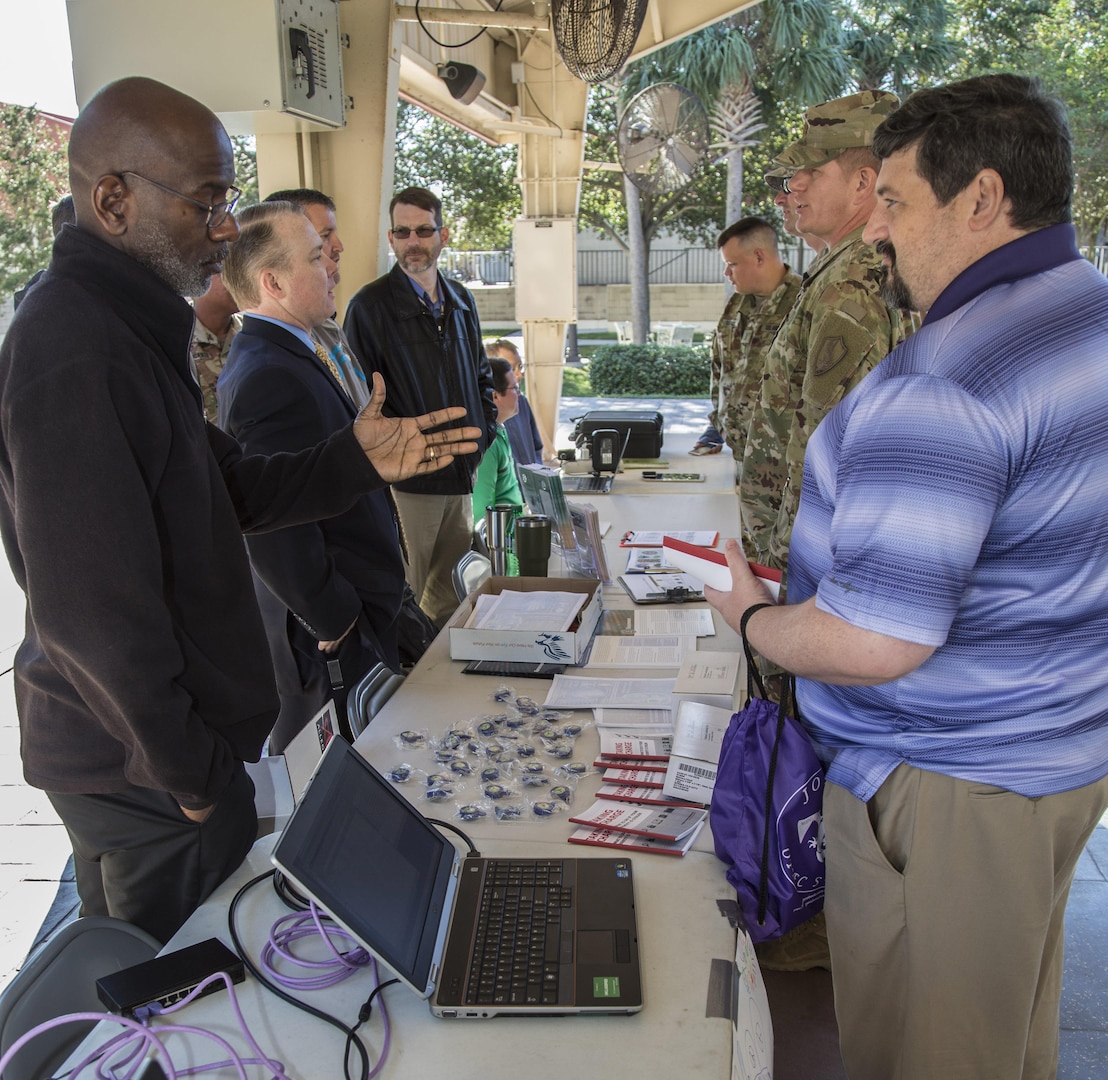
[66,0,346,135]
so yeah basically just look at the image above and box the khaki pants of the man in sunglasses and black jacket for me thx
[392,488,473,627]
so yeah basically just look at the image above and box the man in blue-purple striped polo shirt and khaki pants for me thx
[708,74,1108,1080]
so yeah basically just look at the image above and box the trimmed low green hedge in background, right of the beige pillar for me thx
[588,344,710,398]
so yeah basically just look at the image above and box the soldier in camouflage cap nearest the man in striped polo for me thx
[739,91,919,570]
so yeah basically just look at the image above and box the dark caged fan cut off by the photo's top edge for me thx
[552,0,648,82]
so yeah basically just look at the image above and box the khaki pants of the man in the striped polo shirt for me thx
[823,764,1108,1080]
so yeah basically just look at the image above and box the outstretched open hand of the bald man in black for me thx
[353,371,481,484]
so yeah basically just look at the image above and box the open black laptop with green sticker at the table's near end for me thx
[273,739,643,1019]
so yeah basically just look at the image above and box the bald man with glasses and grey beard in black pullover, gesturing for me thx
[0,78,481,940]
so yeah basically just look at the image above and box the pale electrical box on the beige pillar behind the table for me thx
[512,217,577,322]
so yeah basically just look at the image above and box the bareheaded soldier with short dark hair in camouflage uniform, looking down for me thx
[709,217,800,476]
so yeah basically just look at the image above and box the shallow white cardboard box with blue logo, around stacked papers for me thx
[447,577,604,664]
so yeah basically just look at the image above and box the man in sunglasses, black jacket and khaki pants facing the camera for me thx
[343,187,496,626]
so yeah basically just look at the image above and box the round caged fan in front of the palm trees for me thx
[616,82,711,194]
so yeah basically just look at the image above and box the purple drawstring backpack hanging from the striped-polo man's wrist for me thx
[708,627,824,943]
